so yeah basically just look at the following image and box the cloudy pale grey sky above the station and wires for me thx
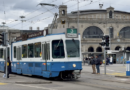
[0,0,130,30]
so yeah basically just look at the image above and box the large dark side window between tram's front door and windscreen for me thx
[52,40,65,58]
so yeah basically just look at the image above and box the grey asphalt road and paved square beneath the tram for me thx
[0,65,130,90]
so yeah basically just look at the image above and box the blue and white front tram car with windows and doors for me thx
[1,33,82,79]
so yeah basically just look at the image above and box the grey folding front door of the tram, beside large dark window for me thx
[42,42,50,71]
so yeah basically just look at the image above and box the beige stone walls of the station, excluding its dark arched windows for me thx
[57,5,130,61]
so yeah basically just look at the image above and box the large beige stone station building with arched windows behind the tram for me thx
[54,5,130,63]
